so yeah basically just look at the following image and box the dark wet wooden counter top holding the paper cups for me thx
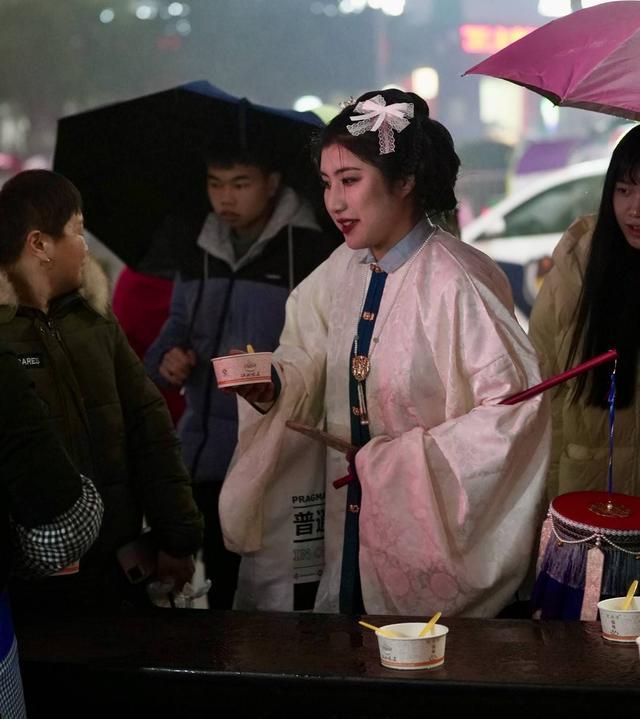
[16,610,640,719]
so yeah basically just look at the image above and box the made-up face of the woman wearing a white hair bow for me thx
[320,145,418,260]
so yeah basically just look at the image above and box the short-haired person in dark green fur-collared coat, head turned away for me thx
[0,170,202,612]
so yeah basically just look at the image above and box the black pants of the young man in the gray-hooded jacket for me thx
[192,482,240,609]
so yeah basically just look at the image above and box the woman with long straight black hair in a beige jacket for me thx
[529,126,640,500]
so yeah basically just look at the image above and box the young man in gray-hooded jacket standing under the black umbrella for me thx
[145,144,339,609]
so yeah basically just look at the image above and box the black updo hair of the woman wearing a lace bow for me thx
[314,89,460,214]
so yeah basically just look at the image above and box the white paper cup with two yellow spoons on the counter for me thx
[376,622,449,670]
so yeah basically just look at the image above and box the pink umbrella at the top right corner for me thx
[464,0,640,120]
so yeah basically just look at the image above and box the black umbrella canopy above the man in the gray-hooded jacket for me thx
[53,81,323,269]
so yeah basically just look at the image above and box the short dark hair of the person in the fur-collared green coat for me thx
[0,170,82,267]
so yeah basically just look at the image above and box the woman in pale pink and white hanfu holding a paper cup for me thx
[220,90,550,617]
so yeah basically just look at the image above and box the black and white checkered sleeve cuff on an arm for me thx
[13,477,104,577]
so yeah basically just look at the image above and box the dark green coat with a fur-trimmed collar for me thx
[0,261,202,608]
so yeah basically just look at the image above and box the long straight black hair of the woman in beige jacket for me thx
[567,126,640,407]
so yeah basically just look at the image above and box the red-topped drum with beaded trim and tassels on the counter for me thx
[532,492,640,620]
